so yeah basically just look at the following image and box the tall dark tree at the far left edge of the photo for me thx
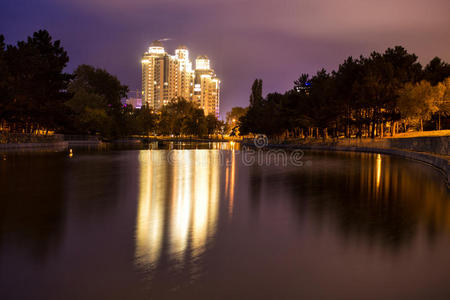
[0,30,71,132]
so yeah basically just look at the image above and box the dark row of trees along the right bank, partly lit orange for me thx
[239,46,450,137]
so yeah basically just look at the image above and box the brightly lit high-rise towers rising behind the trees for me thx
[141,41,220,117]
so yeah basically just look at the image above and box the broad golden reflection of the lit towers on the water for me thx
[136,150,220,267]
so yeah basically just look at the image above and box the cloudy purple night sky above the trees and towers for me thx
[0,0,450,116]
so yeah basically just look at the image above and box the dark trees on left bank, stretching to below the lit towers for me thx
[0,30,222,138]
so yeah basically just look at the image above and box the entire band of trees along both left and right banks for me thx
[0,30,450,138]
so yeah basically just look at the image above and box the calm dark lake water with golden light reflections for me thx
[0,144,450,299]
